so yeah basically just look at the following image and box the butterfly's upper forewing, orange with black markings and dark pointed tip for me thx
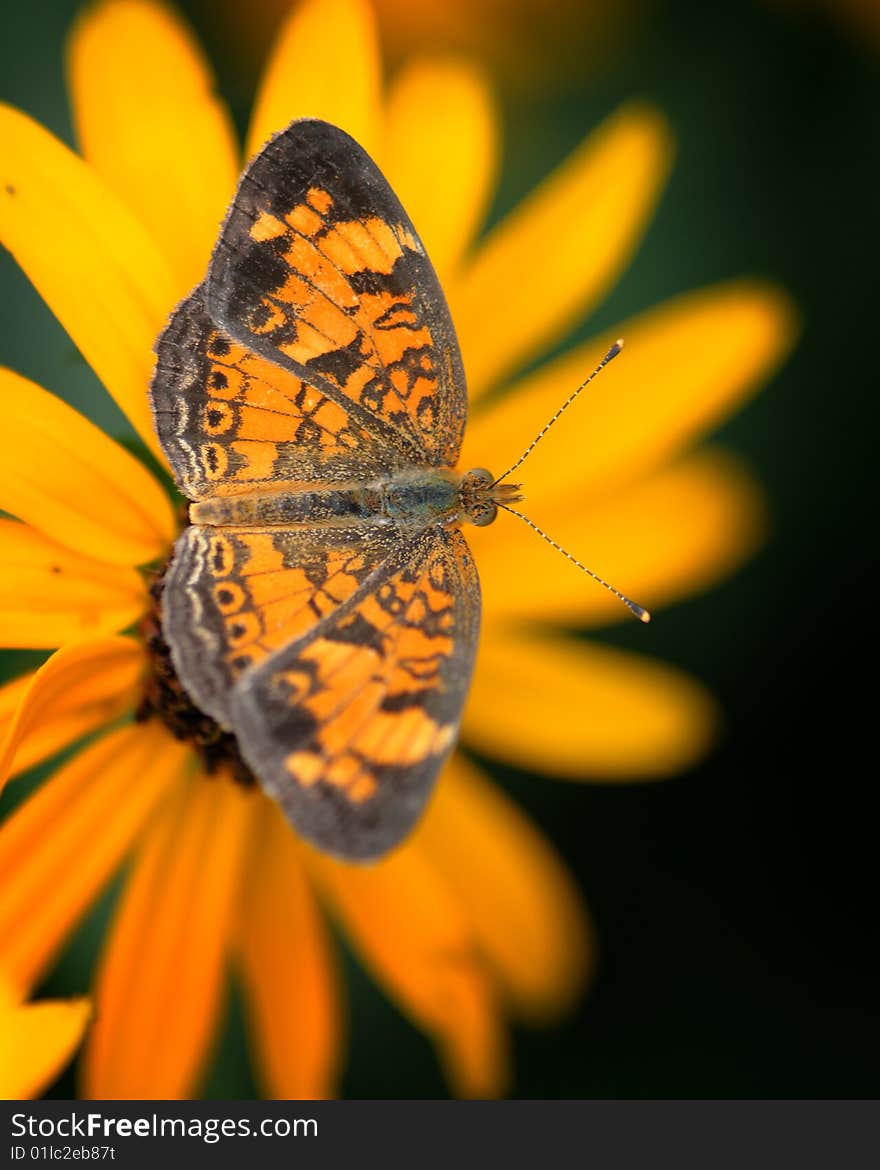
[206,118,467,467]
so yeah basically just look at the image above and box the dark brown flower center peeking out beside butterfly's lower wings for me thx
[136,565,256,787]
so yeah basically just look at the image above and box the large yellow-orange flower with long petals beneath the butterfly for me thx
[0,0,792,1097]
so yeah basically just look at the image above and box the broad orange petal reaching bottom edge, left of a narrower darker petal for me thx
[83,775,255,1100]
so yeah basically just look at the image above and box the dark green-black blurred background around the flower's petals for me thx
[0,0,880,1097]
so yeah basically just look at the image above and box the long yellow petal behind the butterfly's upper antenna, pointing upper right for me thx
[462,281,797,502]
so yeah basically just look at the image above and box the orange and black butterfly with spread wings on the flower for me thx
[150,118,520,860]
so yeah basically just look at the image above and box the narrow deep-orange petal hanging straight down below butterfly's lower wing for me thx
[238,799,341,1100]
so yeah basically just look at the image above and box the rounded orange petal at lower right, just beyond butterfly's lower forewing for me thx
[419,756,594,1020]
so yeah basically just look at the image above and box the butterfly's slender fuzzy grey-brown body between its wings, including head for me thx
[190,468,520,534]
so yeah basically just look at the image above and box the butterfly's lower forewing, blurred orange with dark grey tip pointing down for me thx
[231,528,480,860]
